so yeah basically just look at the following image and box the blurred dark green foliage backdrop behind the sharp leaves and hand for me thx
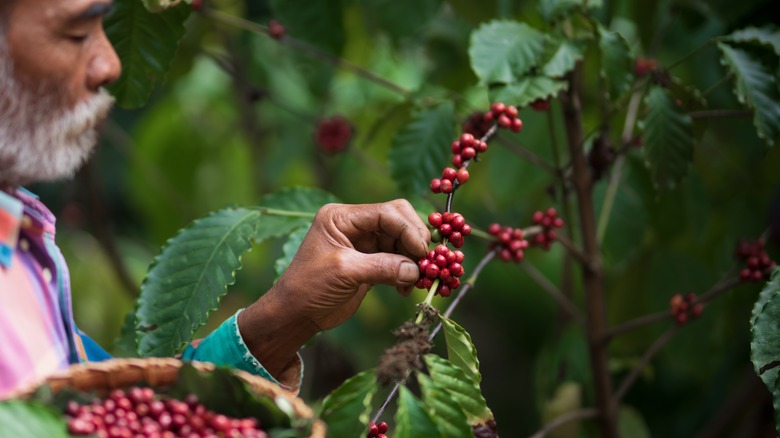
[27,0,780,437]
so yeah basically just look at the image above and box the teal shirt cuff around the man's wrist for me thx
[182,309,303,394]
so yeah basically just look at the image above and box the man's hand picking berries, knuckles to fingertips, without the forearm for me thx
[270,200,430,330]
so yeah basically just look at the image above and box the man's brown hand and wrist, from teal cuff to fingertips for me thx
[239,200,431,374]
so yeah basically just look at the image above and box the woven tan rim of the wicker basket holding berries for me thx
[23,358,326,438]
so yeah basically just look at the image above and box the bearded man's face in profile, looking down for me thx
[0,0,121,187]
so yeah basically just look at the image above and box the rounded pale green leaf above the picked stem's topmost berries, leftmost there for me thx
[469,21,545,84]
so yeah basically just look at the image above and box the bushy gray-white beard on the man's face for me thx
[0,38,114,188]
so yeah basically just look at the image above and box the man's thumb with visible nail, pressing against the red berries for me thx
[349,251,420,286]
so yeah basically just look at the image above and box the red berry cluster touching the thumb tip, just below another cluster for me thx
[417,245,466,298]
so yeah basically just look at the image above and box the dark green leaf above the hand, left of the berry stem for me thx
[388,102,456,194]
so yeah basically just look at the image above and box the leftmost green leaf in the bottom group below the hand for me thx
[320,370,377,437]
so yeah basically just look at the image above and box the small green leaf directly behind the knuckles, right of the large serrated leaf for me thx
[254,187,339,243]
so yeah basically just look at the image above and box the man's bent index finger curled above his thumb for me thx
[342,199,431,257]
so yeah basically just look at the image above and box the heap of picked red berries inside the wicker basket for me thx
[65,387,268,438]
